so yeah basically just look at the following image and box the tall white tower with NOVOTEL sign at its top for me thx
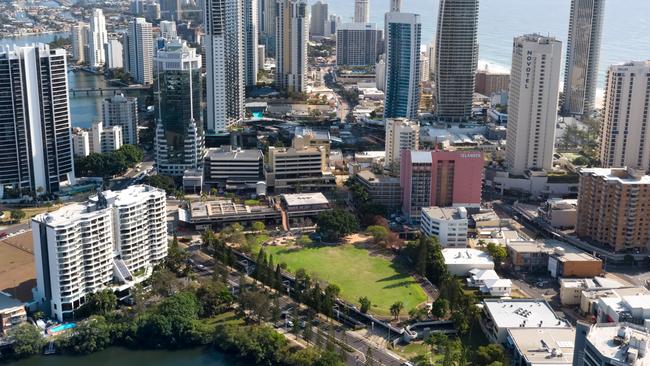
[506,34,562,175]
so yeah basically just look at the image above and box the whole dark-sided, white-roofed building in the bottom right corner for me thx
[573,322,650,366]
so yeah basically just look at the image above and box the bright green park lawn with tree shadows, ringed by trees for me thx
[265,245,427,316]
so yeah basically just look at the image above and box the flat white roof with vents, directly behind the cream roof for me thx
[483,299,569,328]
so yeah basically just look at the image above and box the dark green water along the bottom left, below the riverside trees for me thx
[0,347,252,366]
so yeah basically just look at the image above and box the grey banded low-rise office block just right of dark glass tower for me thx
[203,146,264,190]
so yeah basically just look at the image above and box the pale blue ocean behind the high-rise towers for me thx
[326,0,650,88]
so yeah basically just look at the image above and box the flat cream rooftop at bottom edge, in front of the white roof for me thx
[508,328,576,365]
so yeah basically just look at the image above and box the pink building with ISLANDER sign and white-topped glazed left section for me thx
[400,150,484,220]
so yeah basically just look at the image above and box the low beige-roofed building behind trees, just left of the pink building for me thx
[355,170,402,212]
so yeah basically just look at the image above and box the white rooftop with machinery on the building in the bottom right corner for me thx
[587,323,650,366]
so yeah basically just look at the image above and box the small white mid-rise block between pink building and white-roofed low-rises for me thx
[420,206,467,248]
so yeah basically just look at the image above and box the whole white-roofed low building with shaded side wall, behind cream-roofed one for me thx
[481,299,570,343]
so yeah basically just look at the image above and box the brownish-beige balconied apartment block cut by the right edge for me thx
[576,168,650,253]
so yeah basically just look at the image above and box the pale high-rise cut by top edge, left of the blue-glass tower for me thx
[275,0,309,93]
